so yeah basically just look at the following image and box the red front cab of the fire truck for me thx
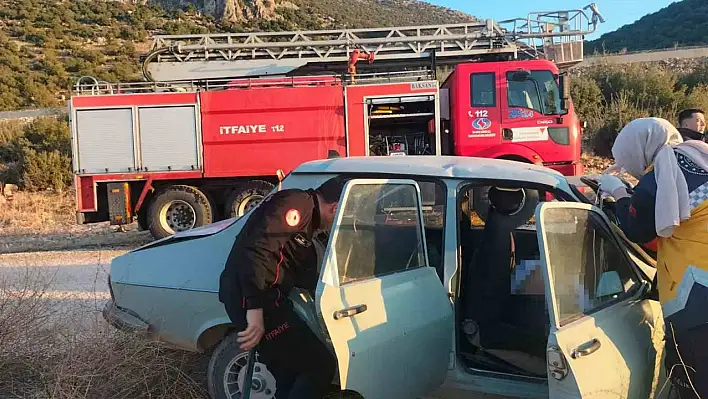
[441,60,584,176]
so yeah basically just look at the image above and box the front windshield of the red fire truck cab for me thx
[506,70,561,115]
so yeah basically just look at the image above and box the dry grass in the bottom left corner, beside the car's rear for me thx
[0,260,208,399]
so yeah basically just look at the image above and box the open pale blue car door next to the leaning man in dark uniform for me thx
[317,179,454,399]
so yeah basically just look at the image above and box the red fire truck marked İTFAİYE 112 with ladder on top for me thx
[69,4,604,238]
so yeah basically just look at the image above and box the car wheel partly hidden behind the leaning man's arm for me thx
[207,333,277,399]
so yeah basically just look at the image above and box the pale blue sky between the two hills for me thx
[427,0,676,40]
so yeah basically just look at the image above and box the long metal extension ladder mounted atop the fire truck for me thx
[143,3,604,82]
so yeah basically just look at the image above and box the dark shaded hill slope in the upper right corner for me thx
[585,0,708,54]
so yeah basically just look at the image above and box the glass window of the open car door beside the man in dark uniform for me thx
[332,184,427,284]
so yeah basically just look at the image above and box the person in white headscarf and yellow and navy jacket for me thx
[598,118,708,399]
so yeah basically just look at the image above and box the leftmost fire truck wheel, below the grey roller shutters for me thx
[147,185,214,239]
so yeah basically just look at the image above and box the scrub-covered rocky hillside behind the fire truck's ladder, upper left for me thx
[0,0,474,111]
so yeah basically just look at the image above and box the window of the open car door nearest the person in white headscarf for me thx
[543,208,639,326]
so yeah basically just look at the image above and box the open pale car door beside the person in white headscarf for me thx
[536,202,666,399]
